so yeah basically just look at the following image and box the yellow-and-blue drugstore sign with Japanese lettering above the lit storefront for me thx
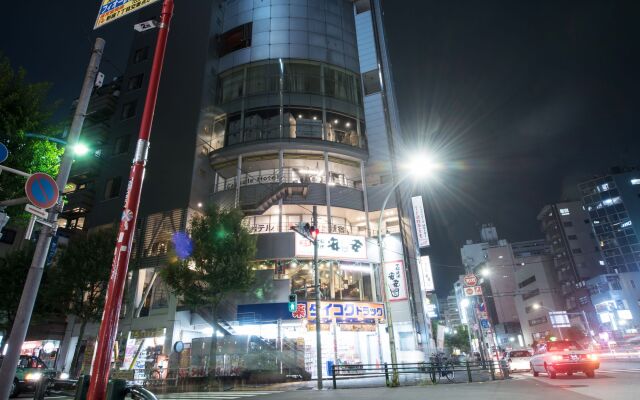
[307,301,384,323]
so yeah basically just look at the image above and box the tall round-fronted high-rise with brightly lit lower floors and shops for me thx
[51,0,431,380]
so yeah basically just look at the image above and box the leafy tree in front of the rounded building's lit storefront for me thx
[160,206,256,375]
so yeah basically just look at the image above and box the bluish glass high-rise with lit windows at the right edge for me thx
[579,168,640,337]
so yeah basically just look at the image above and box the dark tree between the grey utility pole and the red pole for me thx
[45,228,116,372]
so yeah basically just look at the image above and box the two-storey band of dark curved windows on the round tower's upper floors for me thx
[205,60,366,150]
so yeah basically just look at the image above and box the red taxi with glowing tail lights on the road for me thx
[530,340,600,379]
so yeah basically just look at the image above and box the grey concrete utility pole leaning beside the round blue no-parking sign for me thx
[0,38,105,400]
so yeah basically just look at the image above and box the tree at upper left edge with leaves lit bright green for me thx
[0,54,63,215]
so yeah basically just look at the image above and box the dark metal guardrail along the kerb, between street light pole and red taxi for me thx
[330,361,509,389]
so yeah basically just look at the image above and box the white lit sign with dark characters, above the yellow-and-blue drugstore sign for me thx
[295,233,367,261]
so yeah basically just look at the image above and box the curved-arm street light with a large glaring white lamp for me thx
[378,155,441,386]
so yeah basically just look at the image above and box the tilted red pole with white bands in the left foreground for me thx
[87,0,174,400]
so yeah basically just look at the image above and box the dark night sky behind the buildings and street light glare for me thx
[0,0,640,295]
